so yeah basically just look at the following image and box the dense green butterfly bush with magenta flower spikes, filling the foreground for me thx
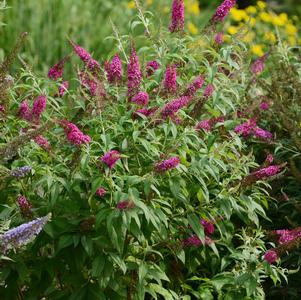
[0,0,301,300]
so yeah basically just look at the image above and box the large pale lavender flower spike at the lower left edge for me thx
[0,215,50,253]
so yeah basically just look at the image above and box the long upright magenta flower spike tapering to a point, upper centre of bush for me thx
[127,47,142,97]
